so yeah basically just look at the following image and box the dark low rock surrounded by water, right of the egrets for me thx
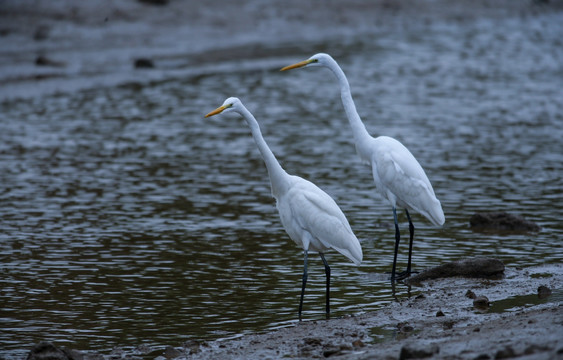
[469,212,540,231]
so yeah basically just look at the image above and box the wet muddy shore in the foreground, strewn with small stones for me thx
[30,265,563,360]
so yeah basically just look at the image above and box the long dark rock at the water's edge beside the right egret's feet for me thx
[406,257,504,286]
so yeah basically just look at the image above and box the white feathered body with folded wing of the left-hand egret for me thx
[277,176,363,265]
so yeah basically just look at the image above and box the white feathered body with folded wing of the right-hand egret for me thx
[372,136,445,226]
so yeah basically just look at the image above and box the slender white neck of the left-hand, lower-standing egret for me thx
[239,106,290,198]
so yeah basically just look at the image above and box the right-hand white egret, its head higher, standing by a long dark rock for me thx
[281,53,445,281]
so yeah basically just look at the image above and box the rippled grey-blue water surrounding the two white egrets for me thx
[0,6,563,357]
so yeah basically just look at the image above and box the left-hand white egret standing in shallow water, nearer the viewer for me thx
[205,97,363,320]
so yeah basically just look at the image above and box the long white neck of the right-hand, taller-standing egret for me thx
[328,59,372,155]
